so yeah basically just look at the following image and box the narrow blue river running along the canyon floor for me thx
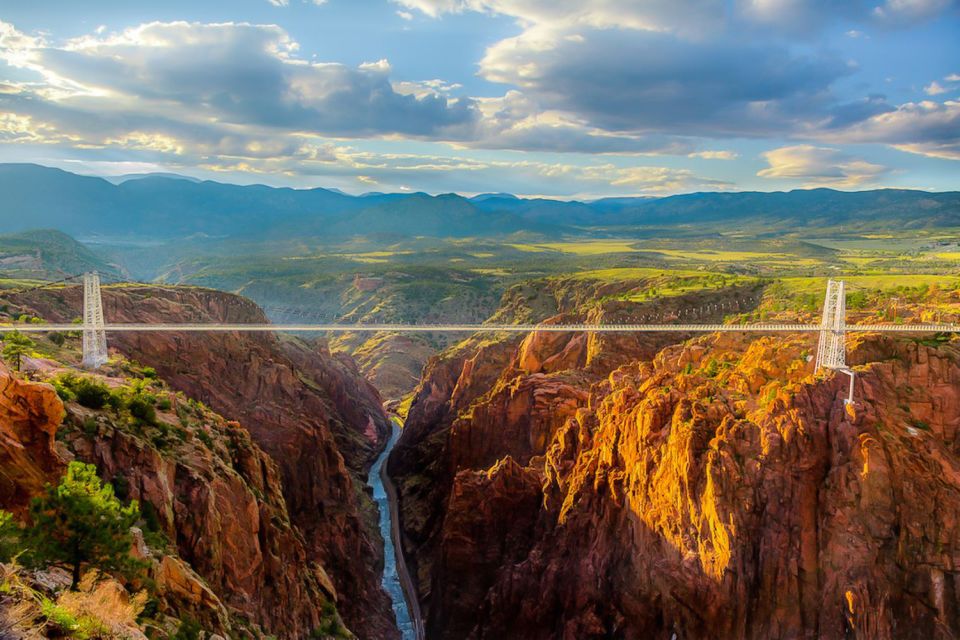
[367,418,423,640]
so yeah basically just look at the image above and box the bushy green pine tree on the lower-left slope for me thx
[25,462,140,590]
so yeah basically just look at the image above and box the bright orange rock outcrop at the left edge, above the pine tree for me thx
[0,363,65,512]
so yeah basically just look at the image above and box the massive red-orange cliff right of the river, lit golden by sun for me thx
[394,310,960,638]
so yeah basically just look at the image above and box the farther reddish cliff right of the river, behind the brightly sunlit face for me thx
[388,280,744,612]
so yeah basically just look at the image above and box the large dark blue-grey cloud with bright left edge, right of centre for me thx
[480,27,852,136]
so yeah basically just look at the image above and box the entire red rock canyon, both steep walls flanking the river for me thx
[0,278,960,640]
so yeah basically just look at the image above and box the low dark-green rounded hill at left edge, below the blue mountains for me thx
[0,229,118,278]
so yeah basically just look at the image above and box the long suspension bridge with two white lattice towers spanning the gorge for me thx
[0,272,960,402]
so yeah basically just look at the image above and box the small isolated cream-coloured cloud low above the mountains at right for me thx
[757,144,890,188]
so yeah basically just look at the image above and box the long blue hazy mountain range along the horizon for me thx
[0,164,960,239]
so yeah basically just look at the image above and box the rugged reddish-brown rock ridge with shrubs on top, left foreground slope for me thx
[63,396,337,637]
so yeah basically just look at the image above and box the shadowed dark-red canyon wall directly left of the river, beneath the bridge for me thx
[22,286,397,639]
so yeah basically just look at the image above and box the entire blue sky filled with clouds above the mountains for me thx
[0,0,960,198]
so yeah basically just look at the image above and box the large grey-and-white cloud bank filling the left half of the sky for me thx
[0,22,478,153]
